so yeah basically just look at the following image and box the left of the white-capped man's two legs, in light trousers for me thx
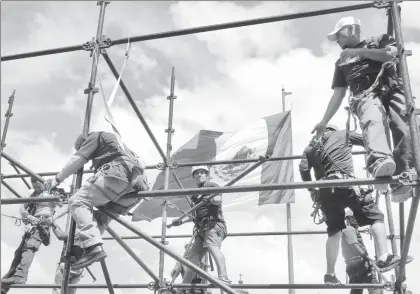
[355,93,396,189]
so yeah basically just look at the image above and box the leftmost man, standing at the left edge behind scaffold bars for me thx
[1,178,62,294]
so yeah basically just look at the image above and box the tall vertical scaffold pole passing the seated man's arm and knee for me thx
[61,1,109,294]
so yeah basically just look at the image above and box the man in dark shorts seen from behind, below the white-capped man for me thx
[299,125,400,285]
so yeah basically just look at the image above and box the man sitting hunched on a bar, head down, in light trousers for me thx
[46,132,148,270]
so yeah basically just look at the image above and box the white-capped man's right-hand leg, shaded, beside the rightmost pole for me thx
[383,89,413,202]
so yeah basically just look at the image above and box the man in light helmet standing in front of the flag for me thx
[182,166,231,292]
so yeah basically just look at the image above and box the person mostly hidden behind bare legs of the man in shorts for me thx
[341,208,413,294]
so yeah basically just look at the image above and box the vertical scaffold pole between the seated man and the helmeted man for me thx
[159,67,176,286]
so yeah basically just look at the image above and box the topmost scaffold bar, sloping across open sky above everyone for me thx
[1,2,374,61]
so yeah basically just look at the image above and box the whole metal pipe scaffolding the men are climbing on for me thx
[1,0,420,294]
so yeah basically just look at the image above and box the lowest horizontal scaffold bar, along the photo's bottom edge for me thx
[10,284,385,290]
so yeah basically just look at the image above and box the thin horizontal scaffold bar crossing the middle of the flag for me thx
[2,151,366,179]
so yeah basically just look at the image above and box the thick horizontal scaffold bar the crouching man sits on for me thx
[1,176,406,205]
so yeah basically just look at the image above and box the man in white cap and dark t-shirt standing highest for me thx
[312,17,413,202]
